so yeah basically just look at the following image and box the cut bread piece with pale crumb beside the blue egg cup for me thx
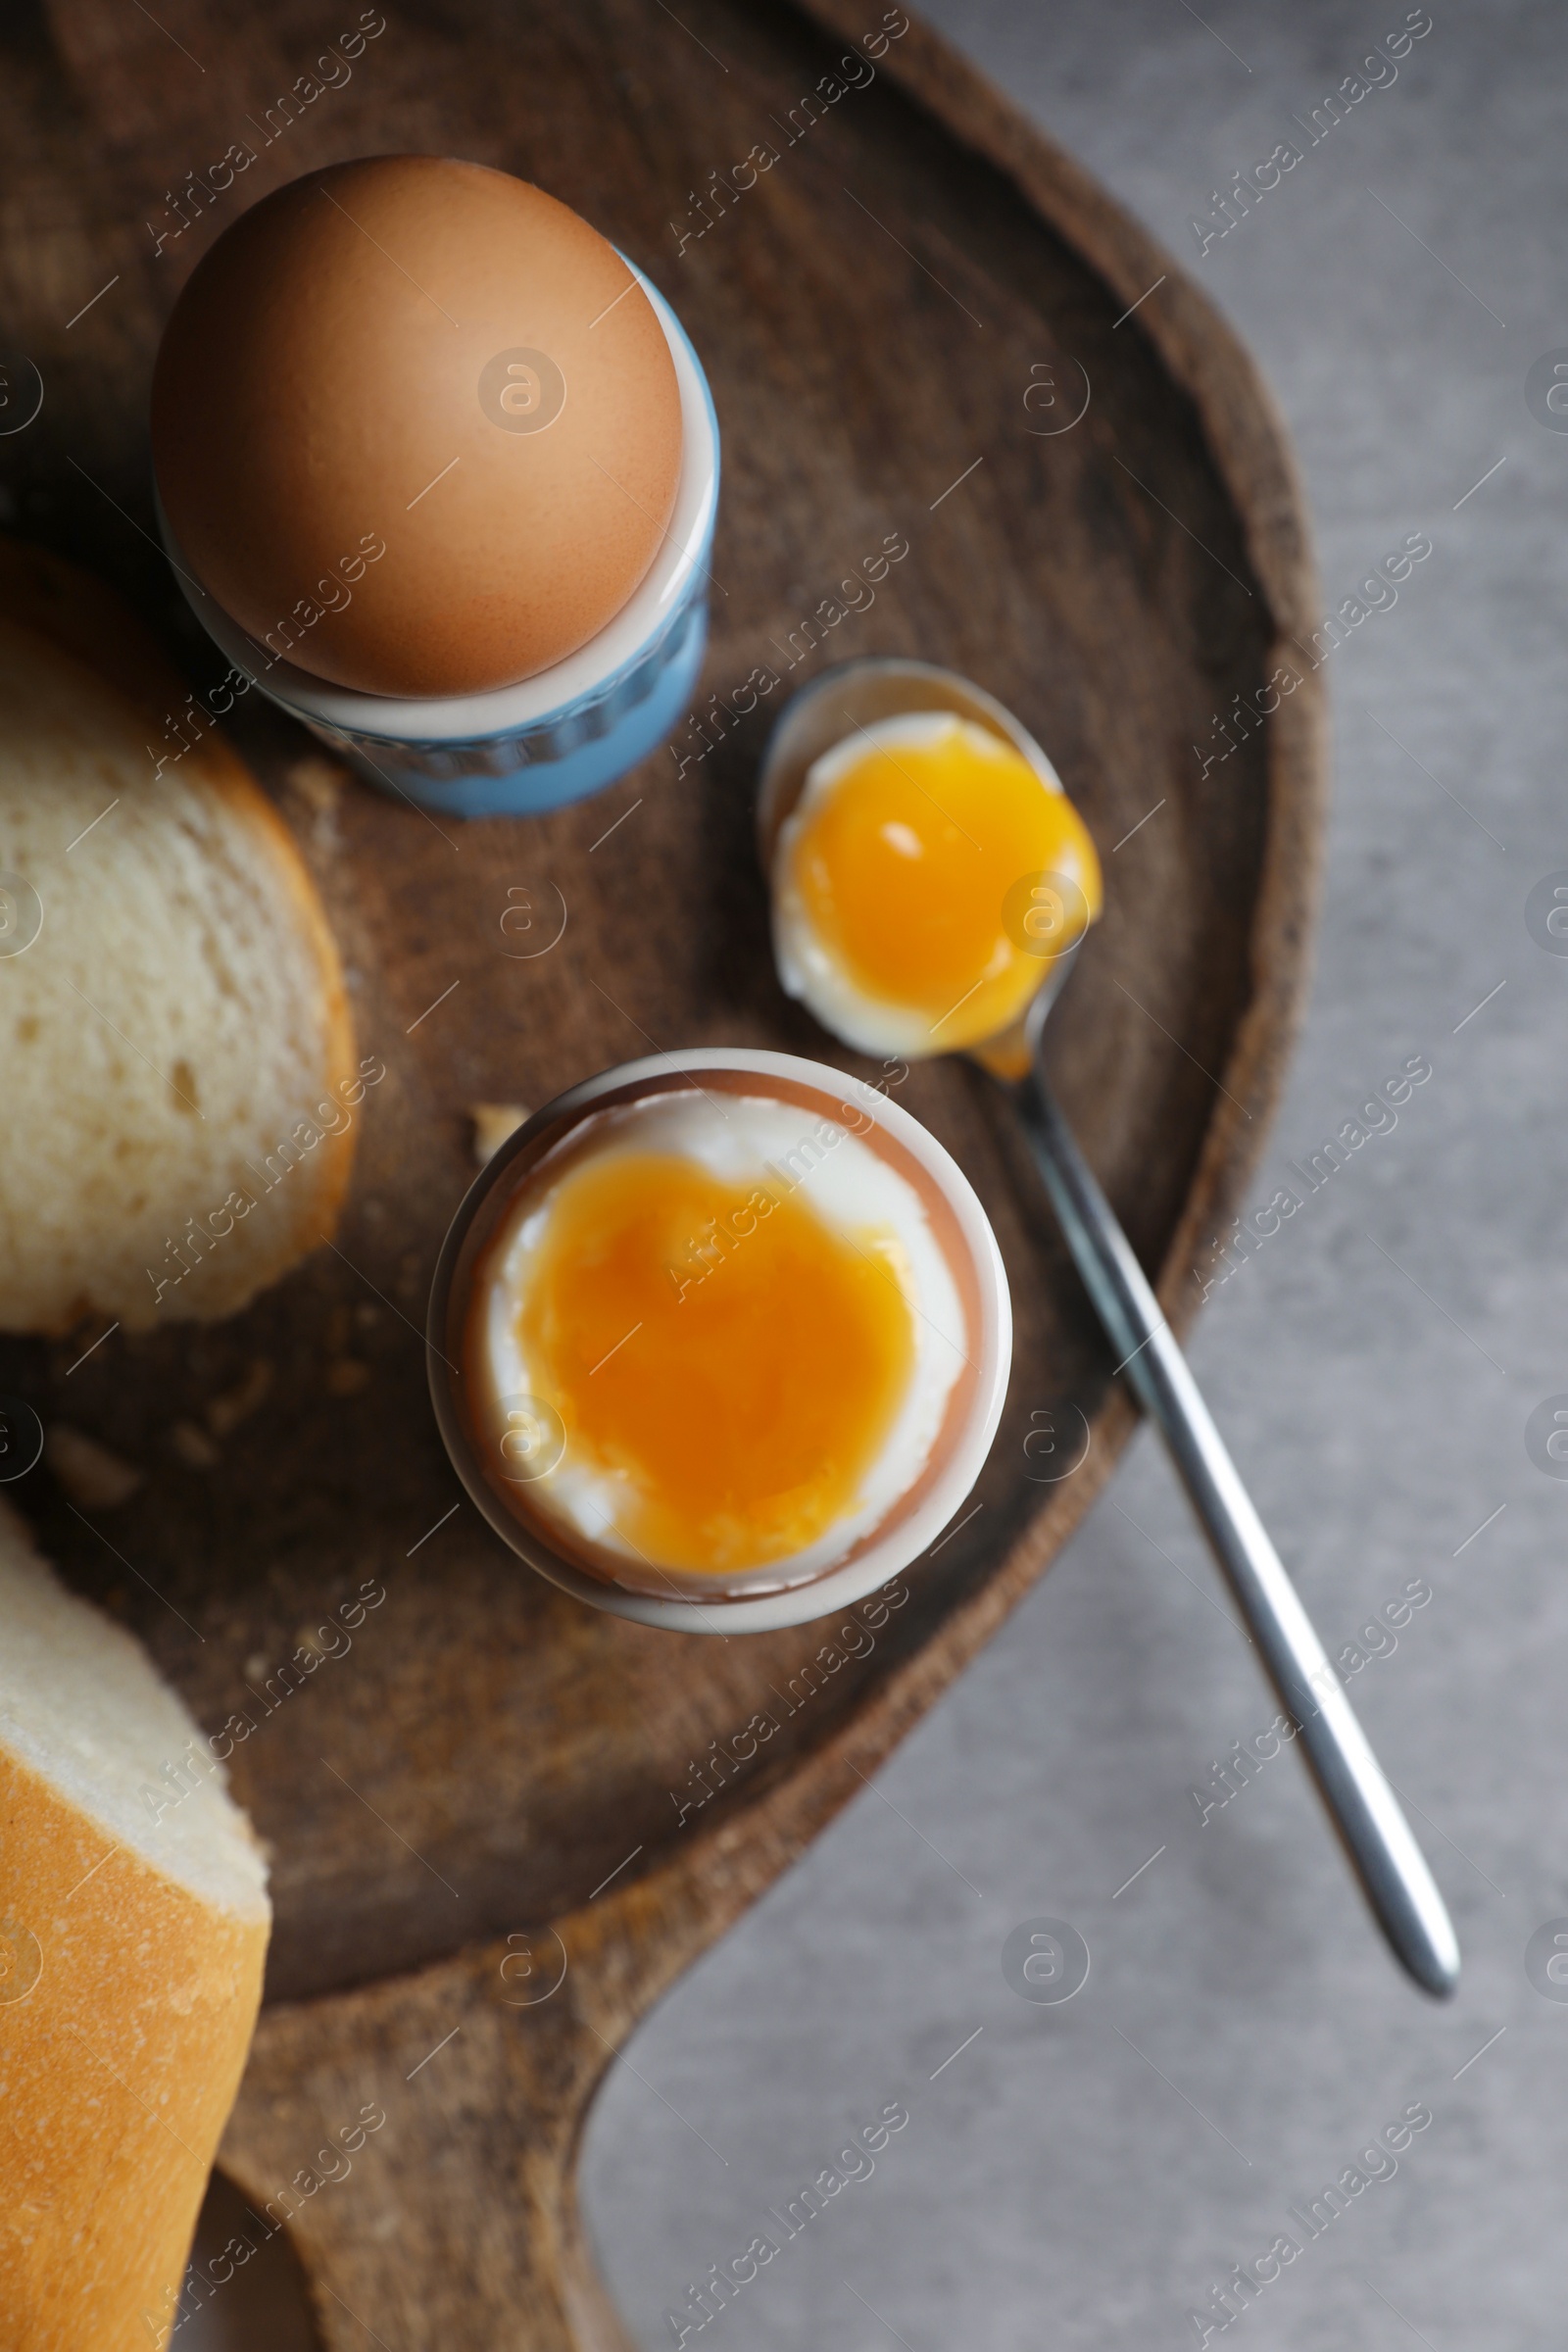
[0,616,360,1331]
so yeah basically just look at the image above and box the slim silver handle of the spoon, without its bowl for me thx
[1013,1072,1460,1994]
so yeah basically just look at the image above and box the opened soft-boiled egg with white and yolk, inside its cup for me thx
[466,1092,976,1590]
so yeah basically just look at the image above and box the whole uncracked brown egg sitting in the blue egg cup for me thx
[153,155,682,696]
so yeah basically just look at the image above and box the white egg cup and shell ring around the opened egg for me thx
[425,1047,1013,1635]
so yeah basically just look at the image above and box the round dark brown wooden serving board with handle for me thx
[0,0,1324,2352]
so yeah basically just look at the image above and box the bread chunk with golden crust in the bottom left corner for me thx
[0,1503,270,2352]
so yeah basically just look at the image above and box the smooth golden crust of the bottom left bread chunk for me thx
[0,1742,268,2352]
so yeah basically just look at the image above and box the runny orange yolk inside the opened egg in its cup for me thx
[503,1151,917,1574]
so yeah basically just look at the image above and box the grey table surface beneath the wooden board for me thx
[181,0,1568,2352]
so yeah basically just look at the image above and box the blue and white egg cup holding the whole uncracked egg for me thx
[155,254,719,816]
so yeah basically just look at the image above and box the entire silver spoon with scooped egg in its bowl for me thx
[757,659,1460,1994]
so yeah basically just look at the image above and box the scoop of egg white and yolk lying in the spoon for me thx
[780,712,1101,1054]
